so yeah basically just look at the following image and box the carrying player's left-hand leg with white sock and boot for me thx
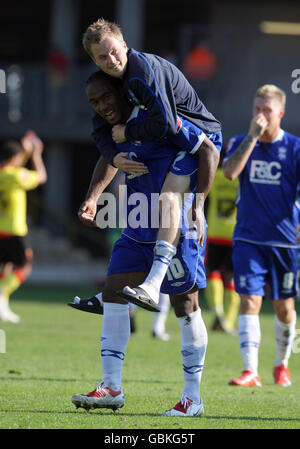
[72,272,146,410]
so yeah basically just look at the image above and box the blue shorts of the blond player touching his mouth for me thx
[232,240,298,299]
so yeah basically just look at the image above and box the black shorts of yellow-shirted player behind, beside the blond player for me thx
[206,242,233,273]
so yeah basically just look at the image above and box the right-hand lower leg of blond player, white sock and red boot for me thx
[273,298,297,387]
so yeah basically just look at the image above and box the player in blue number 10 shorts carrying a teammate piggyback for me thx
[72,71,207,417]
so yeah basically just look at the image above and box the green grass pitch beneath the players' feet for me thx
[0,284,300,430]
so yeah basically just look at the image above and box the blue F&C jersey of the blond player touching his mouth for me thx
[224,130,300,247]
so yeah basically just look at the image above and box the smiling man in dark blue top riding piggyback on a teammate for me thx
[83,18,222,307]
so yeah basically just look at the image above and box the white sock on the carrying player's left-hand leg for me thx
[101,302,130,390]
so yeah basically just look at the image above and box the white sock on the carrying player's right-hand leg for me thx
[178,309,207,404]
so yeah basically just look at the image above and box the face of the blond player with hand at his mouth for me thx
[253,97,284,132]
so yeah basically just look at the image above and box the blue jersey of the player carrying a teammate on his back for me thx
[113,108,197,243]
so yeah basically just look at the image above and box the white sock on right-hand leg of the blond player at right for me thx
[274,311,297,367]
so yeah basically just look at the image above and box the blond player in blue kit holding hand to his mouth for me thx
[223,84,300,387]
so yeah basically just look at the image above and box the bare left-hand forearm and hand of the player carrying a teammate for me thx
[78,156,118,227]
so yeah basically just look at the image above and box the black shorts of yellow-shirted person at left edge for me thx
[0,236,31,267]
